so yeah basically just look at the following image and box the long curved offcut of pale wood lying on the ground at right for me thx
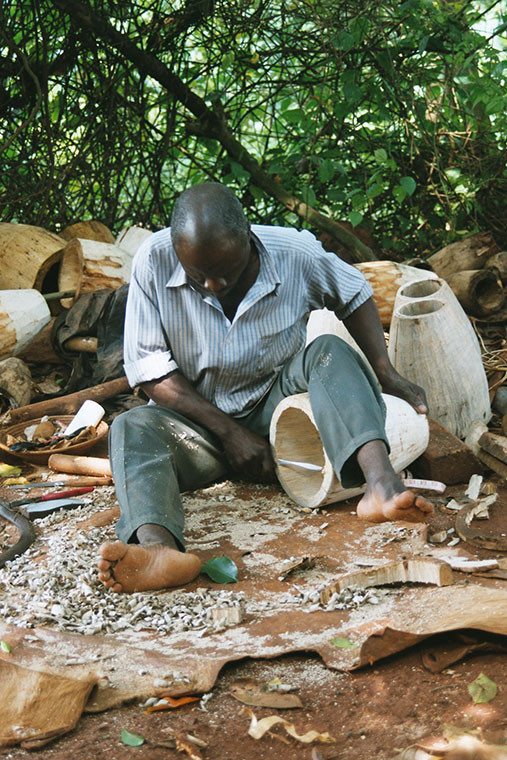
[320,557,453,604]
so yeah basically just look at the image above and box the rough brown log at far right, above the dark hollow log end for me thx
[428,232,500,280]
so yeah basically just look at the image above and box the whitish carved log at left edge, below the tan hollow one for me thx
[0,289,51,358]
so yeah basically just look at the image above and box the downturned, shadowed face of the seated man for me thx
[175,229,251,298]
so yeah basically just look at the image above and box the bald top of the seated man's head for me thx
[171,182,250,252]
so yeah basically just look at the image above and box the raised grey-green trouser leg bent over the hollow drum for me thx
[238,335,389,488]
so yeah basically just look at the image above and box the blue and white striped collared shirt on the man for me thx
[124,225,372,416]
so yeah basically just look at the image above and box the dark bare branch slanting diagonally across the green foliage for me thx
[52,0,376,262]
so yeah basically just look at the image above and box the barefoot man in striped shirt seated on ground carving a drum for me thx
[99,182,432,592]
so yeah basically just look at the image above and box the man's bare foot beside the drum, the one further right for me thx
[357,480,433,522]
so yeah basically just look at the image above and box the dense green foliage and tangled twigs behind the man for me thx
[0,0,507,257]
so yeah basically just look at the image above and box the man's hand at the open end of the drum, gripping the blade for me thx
[221,420,276,483]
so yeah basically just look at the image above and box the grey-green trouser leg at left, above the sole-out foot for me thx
[109,405,227,550]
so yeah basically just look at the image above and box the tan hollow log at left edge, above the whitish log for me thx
[0,222,65,290]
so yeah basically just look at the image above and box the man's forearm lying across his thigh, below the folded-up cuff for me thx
[142,371,235,439]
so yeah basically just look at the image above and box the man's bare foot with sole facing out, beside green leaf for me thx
[98,541,201,593]
